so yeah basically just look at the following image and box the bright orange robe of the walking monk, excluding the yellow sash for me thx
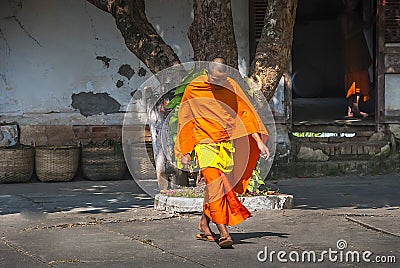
[174,75,268,225]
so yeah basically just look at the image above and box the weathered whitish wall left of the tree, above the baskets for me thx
[0,0,145,113]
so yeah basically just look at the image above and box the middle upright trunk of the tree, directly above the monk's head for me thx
[188,0,238,68]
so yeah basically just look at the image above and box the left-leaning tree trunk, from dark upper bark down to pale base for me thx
[87,0,184,189]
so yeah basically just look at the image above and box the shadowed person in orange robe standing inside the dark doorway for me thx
[341,0,372,118]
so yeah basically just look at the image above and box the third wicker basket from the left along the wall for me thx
[82,145,127,181]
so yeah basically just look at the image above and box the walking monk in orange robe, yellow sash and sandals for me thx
[174,58,270,248]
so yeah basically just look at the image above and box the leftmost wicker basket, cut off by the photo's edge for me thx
[0,146,34,183]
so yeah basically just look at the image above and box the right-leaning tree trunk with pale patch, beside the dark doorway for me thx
[249,0,297,101]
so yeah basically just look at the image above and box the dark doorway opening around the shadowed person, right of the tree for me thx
[292,0,375,124]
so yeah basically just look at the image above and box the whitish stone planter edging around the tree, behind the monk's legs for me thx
[154,194,294,213]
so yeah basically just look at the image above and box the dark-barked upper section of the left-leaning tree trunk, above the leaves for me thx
[87,0,180,73]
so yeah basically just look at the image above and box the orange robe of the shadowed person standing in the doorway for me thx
[342,12,372,101]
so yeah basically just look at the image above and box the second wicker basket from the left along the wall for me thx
[35,146,79,182]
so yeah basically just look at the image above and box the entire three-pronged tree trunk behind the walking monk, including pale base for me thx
[87,0,297,191]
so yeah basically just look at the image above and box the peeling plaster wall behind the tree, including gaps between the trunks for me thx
[0,0,249,124]
